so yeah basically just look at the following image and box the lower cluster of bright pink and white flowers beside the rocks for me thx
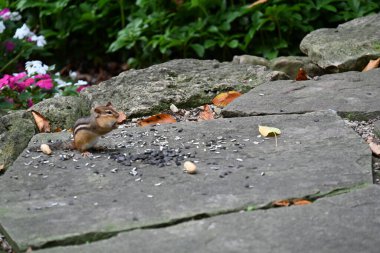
[0,61,87,109]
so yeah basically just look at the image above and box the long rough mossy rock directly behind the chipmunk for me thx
[83,59,281,115]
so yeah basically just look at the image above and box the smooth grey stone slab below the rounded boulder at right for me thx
[222,69,380,117]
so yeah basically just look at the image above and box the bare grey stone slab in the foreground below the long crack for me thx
[33,185,380,253]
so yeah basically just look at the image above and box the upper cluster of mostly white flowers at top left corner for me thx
[0,8,46,75]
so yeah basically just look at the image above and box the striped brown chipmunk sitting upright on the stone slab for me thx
[73,102,119,156]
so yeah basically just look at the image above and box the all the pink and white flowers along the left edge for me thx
[0,8,87,109]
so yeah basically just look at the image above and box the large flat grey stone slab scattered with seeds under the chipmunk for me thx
[0,111,372,252]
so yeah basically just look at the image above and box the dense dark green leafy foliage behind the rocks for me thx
[7,0,380,67]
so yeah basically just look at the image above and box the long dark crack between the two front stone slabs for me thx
[25,183,369,252]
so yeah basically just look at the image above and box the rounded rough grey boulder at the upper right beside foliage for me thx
[300,13,380,73]
